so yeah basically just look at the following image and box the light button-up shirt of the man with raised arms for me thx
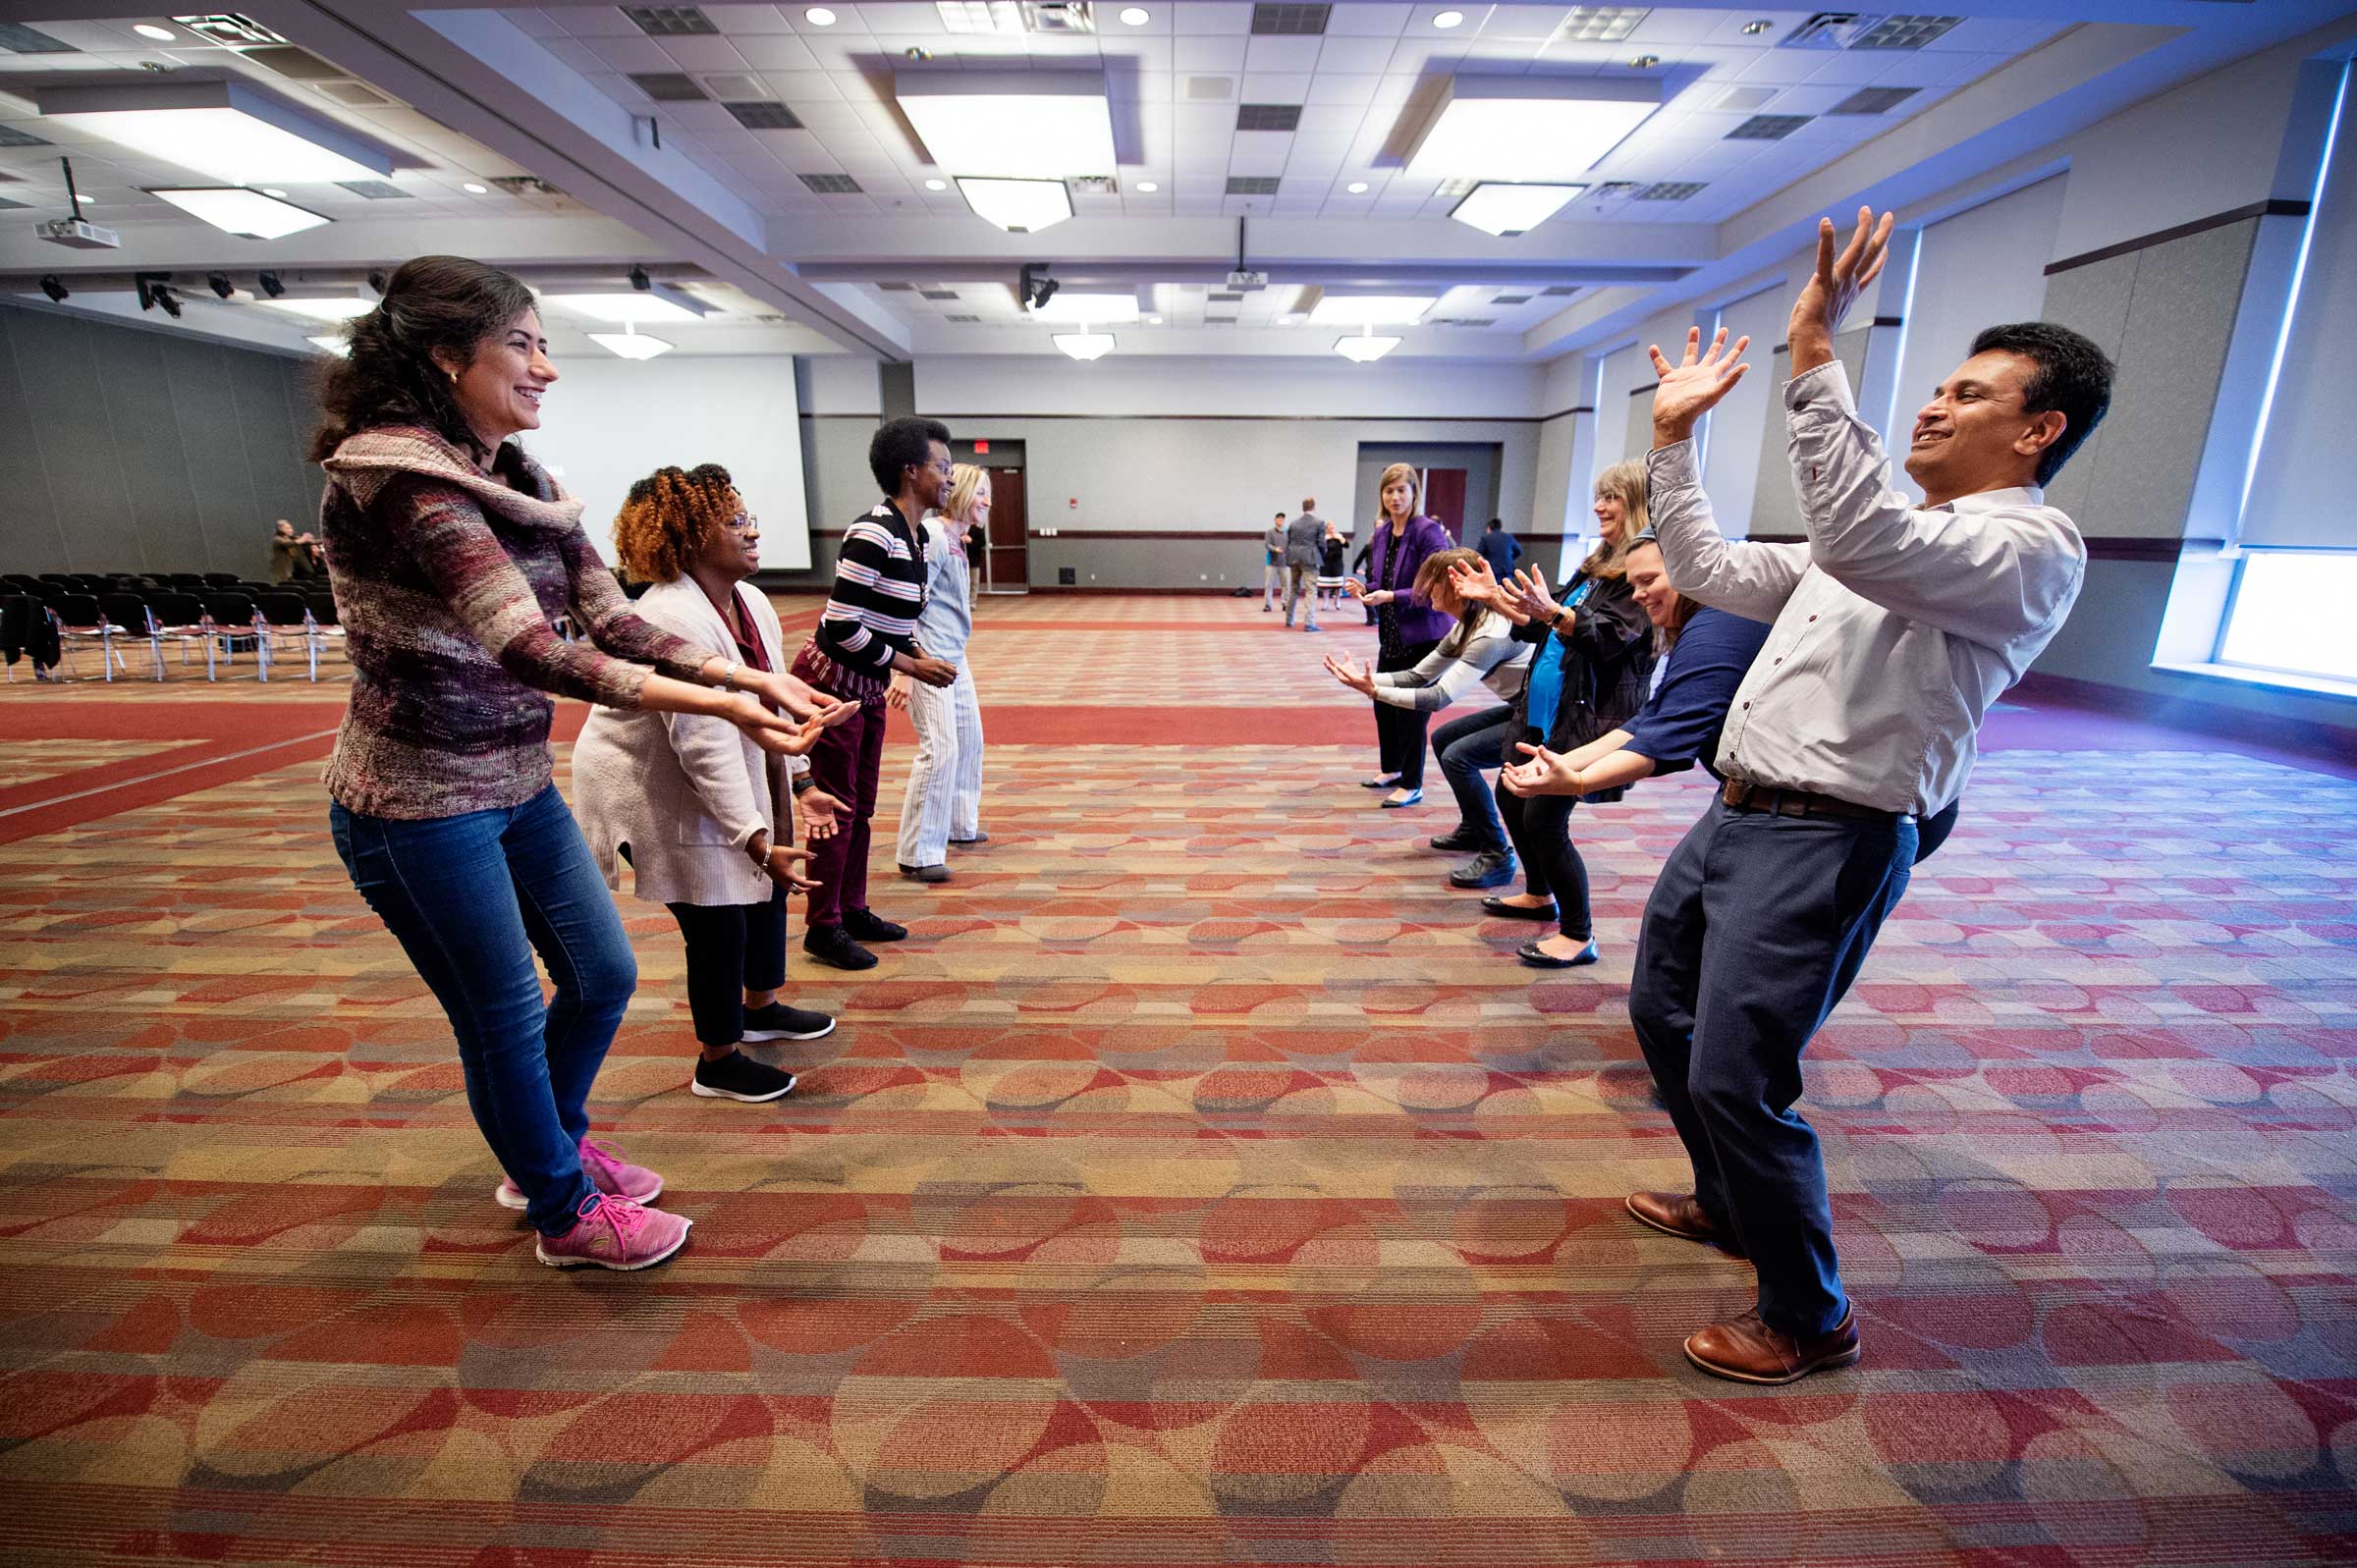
[1645,360,2086,816]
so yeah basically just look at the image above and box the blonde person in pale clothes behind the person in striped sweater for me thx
[884,462,990,882]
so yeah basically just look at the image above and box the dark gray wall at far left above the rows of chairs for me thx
[0,304,320,575]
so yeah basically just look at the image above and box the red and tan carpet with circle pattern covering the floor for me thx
[0,599,2357,1568]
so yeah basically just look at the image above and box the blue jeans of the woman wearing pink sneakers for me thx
[328,785,638,1235]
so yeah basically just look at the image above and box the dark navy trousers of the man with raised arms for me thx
[1628,799,1916,1339]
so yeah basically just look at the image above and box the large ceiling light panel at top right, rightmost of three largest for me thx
[1407,76,1662,184]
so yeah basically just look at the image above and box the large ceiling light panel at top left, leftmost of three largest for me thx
[37,81,394,184]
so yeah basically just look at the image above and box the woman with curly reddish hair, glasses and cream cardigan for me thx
[573,462,842,1104]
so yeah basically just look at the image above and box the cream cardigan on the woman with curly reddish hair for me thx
[573,577,808,905]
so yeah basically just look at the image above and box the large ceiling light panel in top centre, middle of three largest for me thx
[894,71,1115,180]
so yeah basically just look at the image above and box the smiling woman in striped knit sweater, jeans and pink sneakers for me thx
[311,257,835,1269]
